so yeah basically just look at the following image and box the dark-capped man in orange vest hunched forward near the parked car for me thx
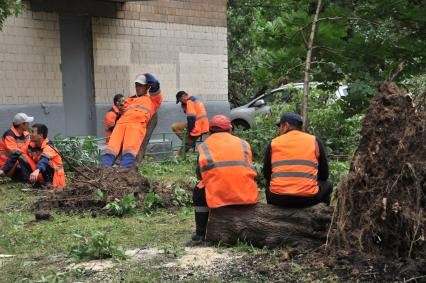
[172,90,209,155]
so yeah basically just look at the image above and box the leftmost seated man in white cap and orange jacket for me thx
[0,113,34,181]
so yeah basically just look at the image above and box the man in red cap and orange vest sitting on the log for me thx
[192,115,258,241]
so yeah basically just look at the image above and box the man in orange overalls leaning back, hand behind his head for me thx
[101,73,163,168]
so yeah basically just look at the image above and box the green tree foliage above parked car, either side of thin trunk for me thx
[228,0,426,106]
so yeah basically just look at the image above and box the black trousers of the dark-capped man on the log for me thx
[265,181,333,208]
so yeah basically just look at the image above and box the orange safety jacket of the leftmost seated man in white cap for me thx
[0,127,30,177]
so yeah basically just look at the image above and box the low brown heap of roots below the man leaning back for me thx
[33,167,190,212]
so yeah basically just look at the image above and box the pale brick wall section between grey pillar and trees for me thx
[92,16,228,103]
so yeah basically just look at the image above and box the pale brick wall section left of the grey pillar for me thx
[0,11,62,104]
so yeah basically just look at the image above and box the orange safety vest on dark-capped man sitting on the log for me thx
[270,130,318,196]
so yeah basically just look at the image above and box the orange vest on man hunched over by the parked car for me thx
[185,96,209,137]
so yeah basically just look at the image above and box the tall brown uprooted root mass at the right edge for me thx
[330,83,426,258]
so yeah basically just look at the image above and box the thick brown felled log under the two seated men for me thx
[206,203,333,248]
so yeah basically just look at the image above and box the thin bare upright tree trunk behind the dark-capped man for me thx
[302,0,321,131]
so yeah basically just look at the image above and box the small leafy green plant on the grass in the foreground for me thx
[69,231,126,261]
